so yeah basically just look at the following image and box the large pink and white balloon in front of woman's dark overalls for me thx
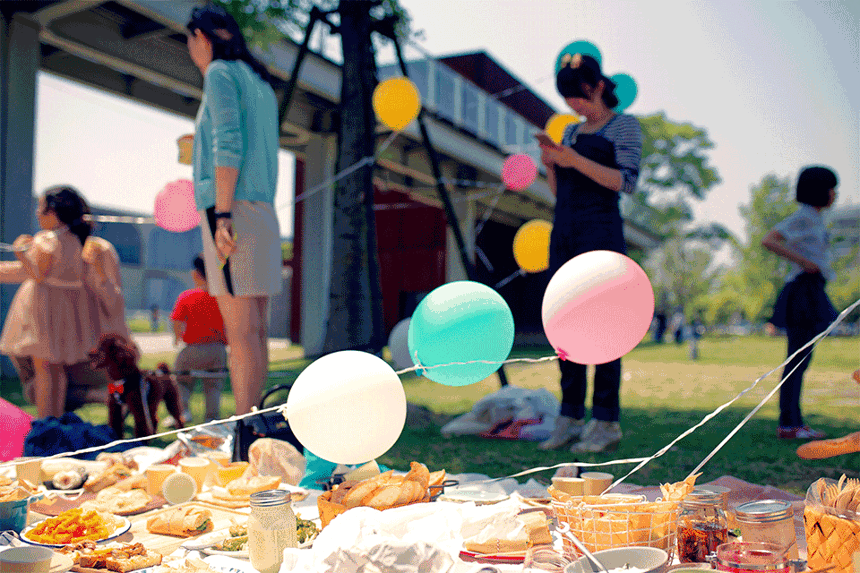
[541,251,654,364]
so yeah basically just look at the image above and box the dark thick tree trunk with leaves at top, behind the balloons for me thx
[218,0,410,353]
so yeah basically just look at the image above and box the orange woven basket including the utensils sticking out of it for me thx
[803,474,860,573]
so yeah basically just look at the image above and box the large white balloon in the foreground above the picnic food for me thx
[287,350,406,464]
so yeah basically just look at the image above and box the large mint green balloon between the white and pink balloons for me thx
[408,281,514,386]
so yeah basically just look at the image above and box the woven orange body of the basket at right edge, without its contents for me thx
[803,505,860,573]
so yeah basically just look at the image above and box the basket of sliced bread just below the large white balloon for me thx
[317,462,445,527]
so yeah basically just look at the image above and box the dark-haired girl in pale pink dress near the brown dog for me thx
[0,186,97,418]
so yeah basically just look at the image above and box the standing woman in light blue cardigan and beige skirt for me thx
[186,5,281,414]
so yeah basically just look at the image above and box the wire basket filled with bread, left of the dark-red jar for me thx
[547,475,697,559]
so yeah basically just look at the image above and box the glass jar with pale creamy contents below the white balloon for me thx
[248,489,299,573]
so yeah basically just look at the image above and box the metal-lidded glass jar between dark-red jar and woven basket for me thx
[735,499,798,559]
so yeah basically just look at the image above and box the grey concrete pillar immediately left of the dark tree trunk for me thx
[296,135,337,356]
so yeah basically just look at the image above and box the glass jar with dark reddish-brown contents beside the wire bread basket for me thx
[678,490,729,563]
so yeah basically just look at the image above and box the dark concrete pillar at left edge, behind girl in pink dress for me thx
[0,14,41,376]
